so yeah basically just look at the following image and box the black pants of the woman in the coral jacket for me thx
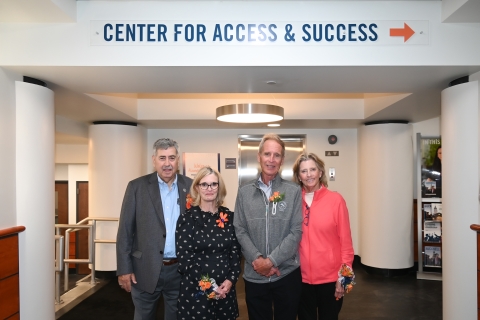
[298,282,343,320]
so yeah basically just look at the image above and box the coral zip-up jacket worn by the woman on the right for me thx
[300,187,353,284]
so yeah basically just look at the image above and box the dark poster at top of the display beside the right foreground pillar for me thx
[420,137,442,198]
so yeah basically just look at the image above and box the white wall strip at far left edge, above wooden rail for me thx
[0,68,22,229]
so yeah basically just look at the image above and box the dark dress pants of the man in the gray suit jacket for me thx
[132,263,181,320]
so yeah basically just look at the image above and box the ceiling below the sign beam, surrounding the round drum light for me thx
[0,0,480,143]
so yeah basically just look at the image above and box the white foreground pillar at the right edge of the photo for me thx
[441,81,479,319]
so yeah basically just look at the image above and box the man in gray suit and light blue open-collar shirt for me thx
[117,139,192,320]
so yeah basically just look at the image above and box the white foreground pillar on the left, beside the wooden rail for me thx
[15,81,55,320]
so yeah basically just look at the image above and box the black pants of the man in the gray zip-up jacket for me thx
[245,268,302,320]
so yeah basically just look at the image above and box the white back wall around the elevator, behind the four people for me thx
[147,129,358,254]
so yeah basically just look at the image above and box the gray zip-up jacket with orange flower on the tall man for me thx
[233,174,302,283]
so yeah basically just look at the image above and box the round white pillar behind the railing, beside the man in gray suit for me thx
[88,124,147,271]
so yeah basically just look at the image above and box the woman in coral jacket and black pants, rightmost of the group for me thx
[293,153,355,320]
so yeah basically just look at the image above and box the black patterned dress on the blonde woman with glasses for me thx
[176,207,240,320]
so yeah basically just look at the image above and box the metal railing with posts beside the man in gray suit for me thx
[55,217,118,304]
